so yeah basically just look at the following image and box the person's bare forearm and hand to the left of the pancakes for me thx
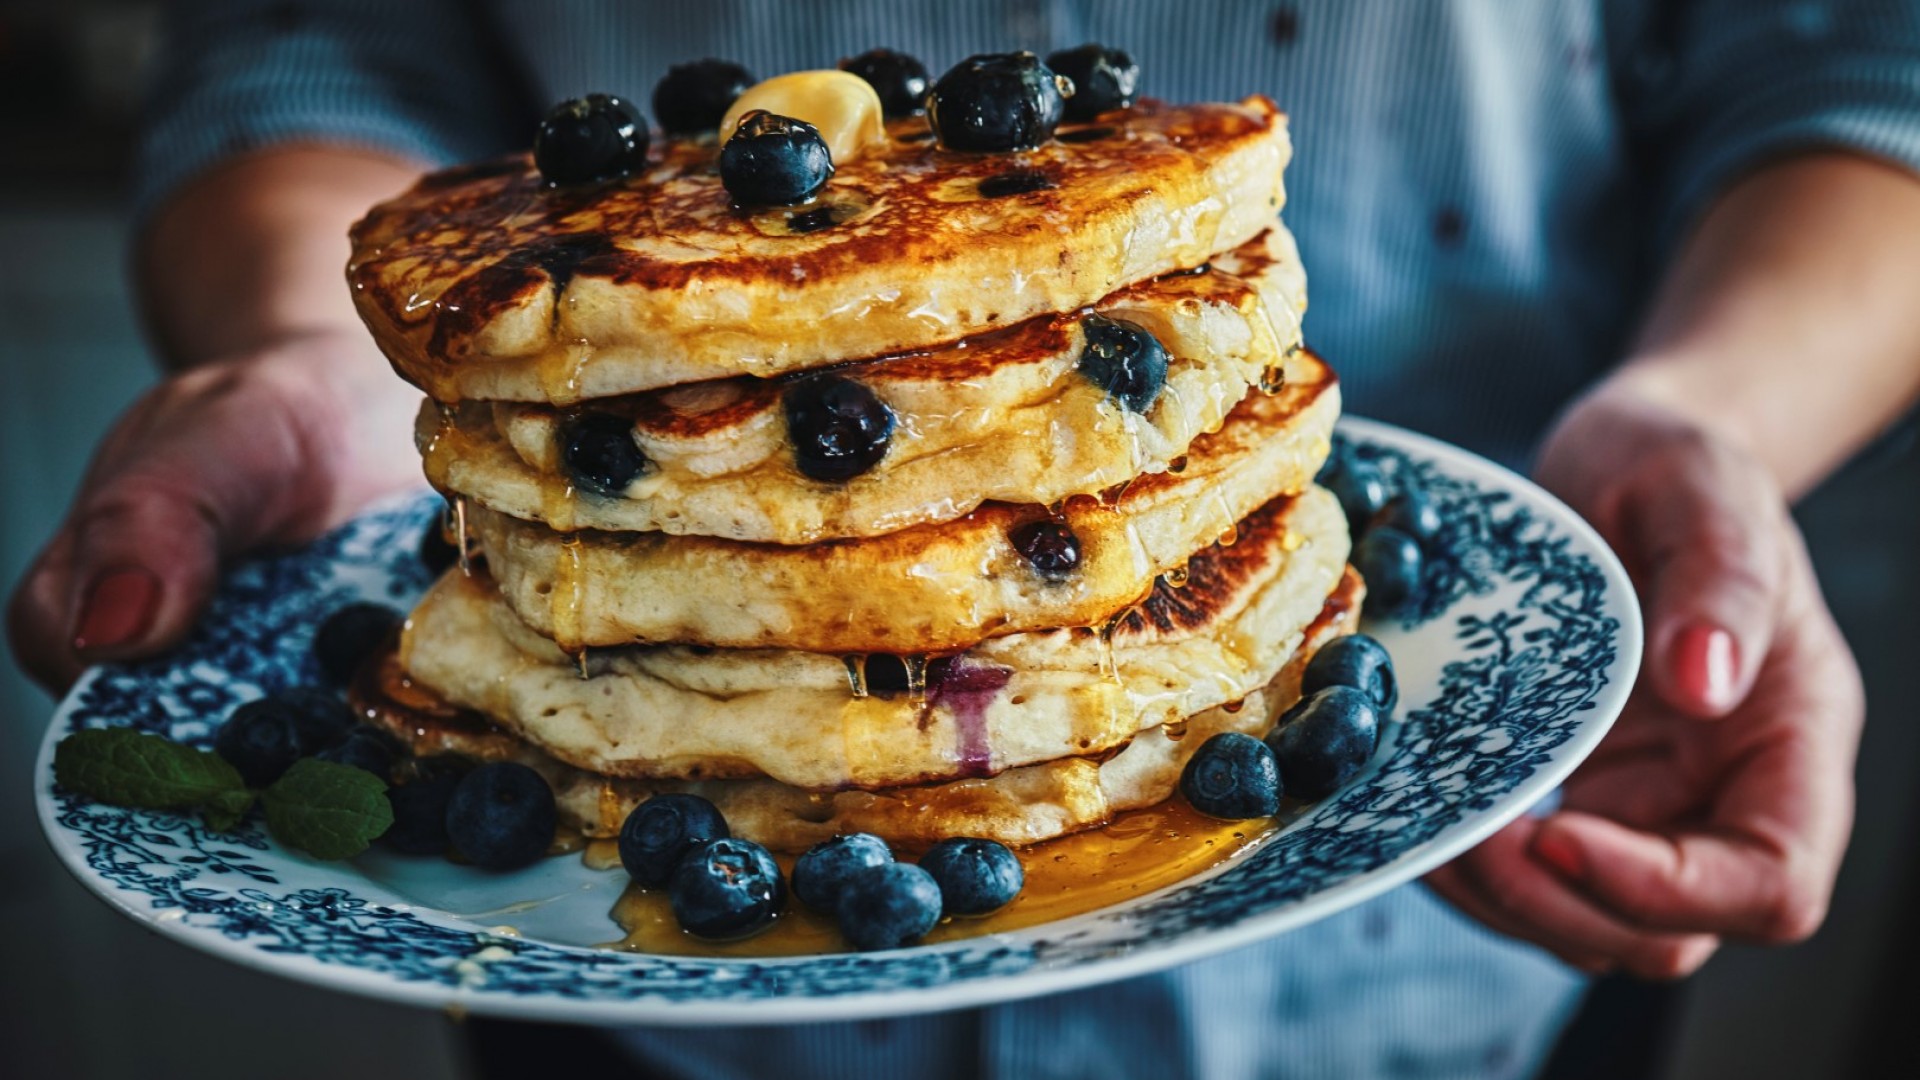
[8,148,420,686]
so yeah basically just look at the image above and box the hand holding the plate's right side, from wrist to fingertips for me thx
[1427,384,1864,978]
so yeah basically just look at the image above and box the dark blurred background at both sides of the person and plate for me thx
[0,0,1920,1080]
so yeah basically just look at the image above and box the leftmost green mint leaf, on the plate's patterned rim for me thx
[54,728,246,813]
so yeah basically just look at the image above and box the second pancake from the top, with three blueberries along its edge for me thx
[419,225,1329,544]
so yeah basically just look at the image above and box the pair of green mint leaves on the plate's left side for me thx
[54,728,394,859]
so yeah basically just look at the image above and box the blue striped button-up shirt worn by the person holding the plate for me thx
[140,0,1920,1080]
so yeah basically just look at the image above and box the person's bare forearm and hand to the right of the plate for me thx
[1428,154,1920,976]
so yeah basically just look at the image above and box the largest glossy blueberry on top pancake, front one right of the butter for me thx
[927,52,1066,154]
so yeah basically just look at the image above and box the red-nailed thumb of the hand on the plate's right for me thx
[1620,444,1791,717]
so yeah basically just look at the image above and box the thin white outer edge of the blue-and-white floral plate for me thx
[33,415,1644,1026]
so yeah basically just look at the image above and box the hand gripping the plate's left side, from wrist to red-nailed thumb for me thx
[8,329,420,690]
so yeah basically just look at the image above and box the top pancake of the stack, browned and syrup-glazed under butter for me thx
[348,96,1290,404]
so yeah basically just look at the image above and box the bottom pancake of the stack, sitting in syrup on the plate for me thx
[353,569,1363,851]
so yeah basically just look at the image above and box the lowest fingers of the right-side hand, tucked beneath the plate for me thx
[1428,821,1718,978]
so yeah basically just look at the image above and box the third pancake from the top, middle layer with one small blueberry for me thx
[467,361,1340,653]
